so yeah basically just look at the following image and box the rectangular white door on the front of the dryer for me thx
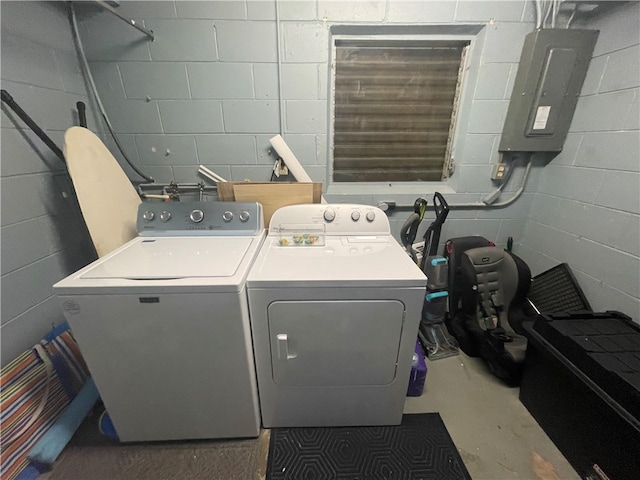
[268,300,405,386]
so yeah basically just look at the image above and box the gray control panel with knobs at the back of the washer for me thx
[137,202,264,236]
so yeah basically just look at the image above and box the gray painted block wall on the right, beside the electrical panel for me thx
[522,2,640,323]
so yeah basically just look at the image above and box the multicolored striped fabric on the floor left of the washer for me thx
[0,324,88,480]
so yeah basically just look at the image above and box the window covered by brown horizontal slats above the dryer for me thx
[332,36,469,182]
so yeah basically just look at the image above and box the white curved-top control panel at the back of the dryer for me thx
[269,204,390,235]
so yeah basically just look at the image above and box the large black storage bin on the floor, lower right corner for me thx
[520,312,640,480]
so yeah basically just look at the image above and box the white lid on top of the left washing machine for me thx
[81,237,254,280]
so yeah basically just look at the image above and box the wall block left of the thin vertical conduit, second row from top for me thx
[215,21,277,63]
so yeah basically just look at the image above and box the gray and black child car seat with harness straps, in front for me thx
[452,247,531,385]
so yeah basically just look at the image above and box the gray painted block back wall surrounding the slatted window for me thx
[72,0,538,248]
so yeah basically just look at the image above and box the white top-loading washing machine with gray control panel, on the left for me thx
[53,202,265,442]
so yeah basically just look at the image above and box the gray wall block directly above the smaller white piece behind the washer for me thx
[196,134,256,165]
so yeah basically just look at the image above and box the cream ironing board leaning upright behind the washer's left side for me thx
[64,127,140,257]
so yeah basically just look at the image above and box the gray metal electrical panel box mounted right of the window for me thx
[498,28,599,152]
